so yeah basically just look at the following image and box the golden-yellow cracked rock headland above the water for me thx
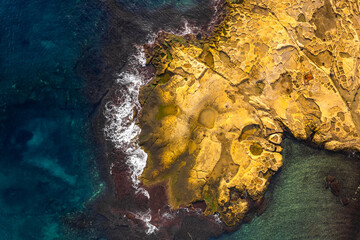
[138,0,360,225]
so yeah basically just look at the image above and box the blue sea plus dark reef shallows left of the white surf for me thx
[0,0,211,240]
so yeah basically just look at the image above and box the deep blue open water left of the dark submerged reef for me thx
[0,0,102,240]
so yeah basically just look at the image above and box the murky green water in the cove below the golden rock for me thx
[215,139,360,240]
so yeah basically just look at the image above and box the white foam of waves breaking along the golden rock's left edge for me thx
[104,21,207,234]
